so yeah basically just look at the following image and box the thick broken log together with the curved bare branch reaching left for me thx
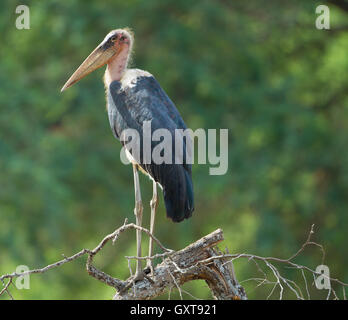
[0,222,246,299]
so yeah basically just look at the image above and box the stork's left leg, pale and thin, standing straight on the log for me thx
[133,164,143,278]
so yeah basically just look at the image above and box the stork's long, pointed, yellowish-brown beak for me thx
[60,40,118,91]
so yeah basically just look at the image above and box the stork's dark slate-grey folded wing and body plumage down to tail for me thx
[108,76,193,221]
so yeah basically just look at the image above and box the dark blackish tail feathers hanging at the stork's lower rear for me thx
[162,166,194,222]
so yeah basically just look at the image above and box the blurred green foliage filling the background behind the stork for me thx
[0,0,348,299]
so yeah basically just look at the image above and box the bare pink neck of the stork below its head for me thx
[104,46,129,88]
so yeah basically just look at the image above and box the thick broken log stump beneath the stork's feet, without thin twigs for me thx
[114,229,246,300]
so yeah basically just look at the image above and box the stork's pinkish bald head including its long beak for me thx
[61,29,133,91]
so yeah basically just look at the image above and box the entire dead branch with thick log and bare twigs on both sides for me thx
[0,221,348,300]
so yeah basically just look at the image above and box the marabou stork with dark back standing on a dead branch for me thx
[61,29,194,279]
